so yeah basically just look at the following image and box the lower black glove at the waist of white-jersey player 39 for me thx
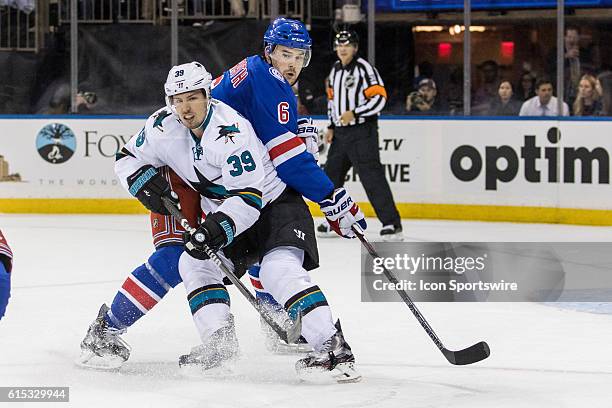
[183,211,236,259]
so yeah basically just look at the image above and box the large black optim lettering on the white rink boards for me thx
[450,127,610,190]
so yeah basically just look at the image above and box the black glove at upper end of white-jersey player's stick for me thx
[127,165,181,215]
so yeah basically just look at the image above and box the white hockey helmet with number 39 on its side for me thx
[164,61,212,114]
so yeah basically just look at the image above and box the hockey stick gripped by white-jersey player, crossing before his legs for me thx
[161,197,302,344]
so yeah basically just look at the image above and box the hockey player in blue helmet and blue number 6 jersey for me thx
[81,18,366,368]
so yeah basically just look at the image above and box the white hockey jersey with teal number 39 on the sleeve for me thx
[115,99,286,235]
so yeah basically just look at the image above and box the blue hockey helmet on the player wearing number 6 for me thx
[264,17,312,67]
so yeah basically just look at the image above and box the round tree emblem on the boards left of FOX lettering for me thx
[36,123,76,164]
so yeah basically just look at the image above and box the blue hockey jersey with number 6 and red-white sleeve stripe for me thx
[212,56,334,203]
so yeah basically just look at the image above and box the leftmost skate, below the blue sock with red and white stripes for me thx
[76,304,131,370]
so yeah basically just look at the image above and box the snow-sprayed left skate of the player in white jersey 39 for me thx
[179,315,240,370]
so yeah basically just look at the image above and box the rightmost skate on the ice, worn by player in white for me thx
[295,320,361,383]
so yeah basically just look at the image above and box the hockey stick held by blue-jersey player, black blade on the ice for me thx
[353,225,491,365]
